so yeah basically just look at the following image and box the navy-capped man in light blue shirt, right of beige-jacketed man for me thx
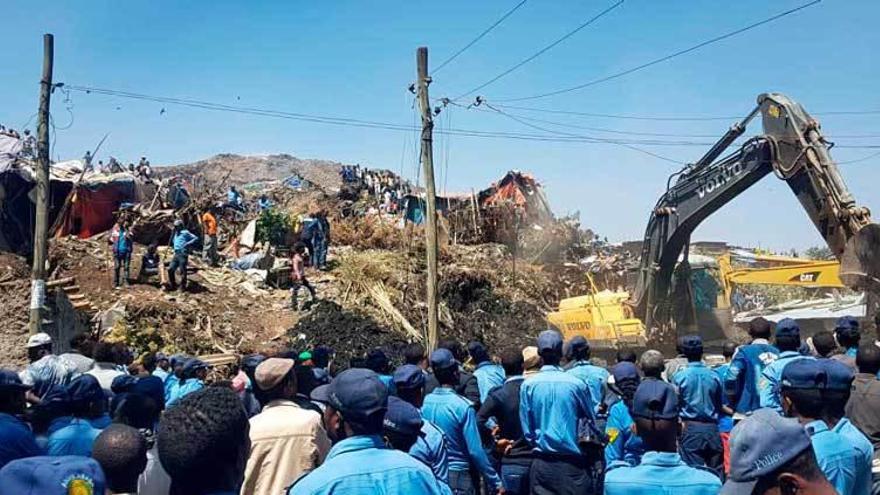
[287,368,448,495]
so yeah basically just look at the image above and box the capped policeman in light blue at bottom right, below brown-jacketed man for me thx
[818,359,874,495]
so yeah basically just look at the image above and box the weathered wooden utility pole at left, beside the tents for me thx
[28,34,55,334]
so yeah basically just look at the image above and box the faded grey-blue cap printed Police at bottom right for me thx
[720,410,811,495]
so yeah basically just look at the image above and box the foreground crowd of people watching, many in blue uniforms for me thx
[0,317,880,495]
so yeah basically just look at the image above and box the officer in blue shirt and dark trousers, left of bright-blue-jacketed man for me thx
[672,335,724,478]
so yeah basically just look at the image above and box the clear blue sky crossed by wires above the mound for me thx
[0,0,880,250]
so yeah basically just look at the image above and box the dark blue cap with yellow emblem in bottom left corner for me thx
[0,455,105,495]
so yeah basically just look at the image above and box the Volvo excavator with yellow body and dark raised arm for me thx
[547,93,880,347]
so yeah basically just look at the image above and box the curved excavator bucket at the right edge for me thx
[840,223,880,294]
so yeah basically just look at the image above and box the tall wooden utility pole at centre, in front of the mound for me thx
[416,46,439,352]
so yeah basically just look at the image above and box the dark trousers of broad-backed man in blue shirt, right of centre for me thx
[529,455,601,495]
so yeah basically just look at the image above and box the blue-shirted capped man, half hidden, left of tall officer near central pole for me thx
[393,364,449,485]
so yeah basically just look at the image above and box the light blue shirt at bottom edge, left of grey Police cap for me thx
[605,451,721,495]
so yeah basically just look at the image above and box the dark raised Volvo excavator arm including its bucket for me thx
[629,93,880,329]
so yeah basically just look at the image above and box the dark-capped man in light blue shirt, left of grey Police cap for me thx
[605,378,721,495]
